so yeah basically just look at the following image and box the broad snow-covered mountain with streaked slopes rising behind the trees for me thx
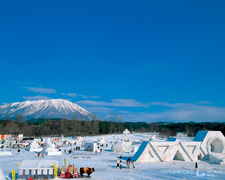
[0,99,94,120]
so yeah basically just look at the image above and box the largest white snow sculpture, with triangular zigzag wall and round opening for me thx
[131,131,225,164]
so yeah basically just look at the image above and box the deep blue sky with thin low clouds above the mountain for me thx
[0,0,225,122]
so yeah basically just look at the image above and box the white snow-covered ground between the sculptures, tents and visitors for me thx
[0,134,225,180]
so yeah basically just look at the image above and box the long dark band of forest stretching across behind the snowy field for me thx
[0,115,225,137]
